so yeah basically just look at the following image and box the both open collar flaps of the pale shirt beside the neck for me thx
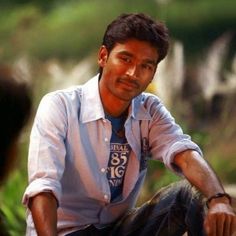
[80,75,151,123]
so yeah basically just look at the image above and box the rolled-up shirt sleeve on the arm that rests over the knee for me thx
[149,97,202,174]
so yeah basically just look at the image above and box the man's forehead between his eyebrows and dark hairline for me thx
[110,39,158,61]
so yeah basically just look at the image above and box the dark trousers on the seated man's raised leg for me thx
[68,181,204,236]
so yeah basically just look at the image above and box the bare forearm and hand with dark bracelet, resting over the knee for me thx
[174,150,236,236]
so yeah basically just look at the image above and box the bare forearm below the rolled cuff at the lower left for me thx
[29,192,57,236]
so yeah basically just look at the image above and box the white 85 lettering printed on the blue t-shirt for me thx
[107,143,130,199]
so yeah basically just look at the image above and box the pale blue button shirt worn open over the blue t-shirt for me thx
[23,76,201,235]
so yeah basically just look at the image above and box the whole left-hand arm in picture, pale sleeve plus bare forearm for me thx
[23,94,66,236]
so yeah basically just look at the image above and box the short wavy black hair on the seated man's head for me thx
[102,13,169,62]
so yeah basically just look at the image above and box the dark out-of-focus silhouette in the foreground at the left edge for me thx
[0,65,32,236]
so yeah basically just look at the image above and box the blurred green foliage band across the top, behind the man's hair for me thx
[0,0,236,60]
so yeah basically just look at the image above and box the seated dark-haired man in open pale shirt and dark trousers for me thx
[23,14,236,236]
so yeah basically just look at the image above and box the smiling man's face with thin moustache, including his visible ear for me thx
[98,39,158,101]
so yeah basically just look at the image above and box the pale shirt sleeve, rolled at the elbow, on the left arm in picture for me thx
[22,93,67,205]
